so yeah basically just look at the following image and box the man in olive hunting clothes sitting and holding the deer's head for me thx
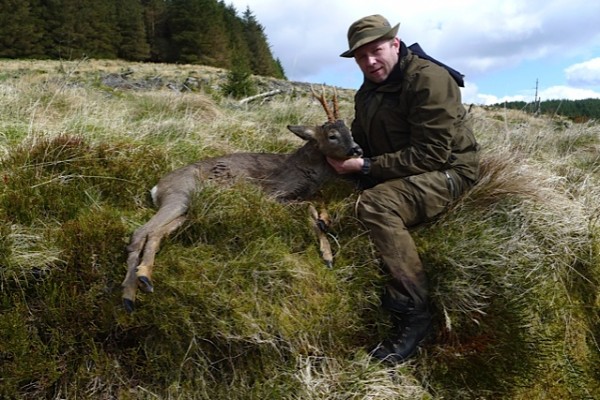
[329,15,479,363]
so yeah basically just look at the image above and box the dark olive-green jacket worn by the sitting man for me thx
[352,43,479,183]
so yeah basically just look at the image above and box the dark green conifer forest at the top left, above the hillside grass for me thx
[0,0,285,79]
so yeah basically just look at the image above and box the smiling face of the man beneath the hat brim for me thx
[354,38,400,83]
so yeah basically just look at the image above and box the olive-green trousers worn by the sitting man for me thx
[356,171,472,308]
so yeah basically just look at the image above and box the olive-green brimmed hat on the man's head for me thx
[340,14,400,58]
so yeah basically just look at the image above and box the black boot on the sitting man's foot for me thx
[371,308,432,364]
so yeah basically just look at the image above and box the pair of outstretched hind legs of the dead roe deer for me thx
[122,204,187,312]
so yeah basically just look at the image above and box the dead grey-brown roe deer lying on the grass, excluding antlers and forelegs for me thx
[123,117,362,311]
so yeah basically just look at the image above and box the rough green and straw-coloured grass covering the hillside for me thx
[0,61,600,400]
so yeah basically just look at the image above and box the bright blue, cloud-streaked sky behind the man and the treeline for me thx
[225,0,600,104]
